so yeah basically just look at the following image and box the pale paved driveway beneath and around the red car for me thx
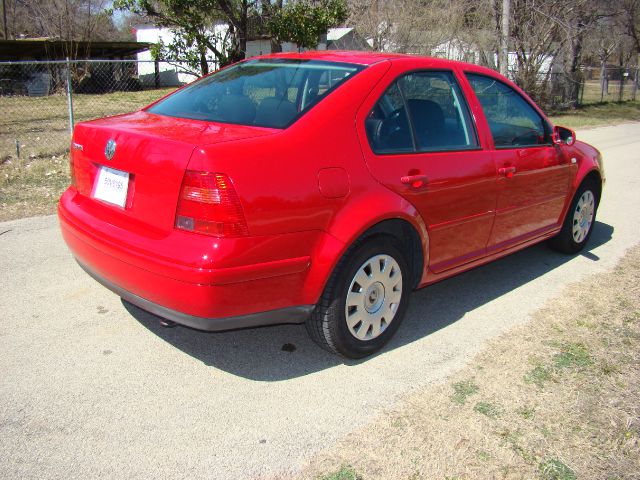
[0,124,640,479]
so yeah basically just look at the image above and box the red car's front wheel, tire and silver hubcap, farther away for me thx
[549,180,600,254]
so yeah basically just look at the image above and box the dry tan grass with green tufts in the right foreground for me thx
[298,247,640,480]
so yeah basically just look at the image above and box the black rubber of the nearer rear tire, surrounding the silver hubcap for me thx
[306,237,412,358]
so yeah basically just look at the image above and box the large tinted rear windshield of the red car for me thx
[148,59,362,128]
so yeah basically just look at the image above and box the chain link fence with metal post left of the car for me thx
[0,60,195,162]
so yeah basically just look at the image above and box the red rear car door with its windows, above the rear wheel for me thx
[358,69,496,272]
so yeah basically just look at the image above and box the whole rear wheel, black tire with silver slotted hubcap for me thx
[306,237,412,358]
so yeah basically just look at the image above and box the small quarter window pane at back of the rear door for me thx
[365,83,413,153]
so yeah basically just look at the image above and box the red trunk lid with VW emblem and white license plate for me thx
[71,111,274,234]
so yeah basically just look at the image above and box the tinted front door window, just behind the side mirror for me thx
[467,73,551,148]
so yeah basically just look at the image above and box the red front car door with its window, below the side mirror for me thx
[466,73,573,252]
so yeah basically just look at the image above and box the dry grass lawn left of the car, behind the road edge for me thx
[0,88,173,221]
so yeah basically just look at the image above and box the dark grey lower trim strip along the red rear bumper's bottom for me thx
[78,261,313,332]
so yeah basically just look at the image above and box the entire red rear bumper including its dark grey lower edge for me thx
[58,189,315,331]
